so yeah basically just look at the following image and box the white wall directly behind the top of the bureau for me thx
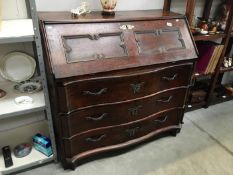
[36,0,164,11]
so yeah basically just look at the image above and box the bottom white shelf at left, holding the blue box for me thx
[0,148,53,175]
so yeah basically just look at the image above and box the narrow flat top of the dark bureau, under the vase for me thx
[39,10,184,23]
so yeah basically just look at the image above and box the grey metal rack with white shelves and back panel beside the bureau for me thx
[0,0,56,174]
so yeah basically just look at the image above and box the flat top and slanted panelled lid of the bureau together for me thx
[39,10,197,79]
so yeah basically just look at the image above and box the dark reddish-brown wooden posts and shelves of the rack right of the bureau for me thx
[163,0,233,111]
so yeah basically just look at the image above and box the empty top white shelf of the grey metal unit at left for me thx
[0,19,34,44]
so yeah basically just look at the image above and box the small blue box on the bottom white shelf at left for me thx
[33,134,53,157]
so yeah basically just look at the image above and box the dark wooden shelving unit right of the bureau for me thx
[163,0,233,111]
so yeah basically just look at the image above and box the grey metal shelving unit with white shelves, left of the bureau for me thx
[0,0,57,175]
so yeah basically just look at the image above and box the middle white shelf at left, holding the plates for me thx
[0,81,45,119]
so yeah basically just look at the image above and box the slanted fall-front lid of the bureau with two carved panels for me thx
[42,19,196,78]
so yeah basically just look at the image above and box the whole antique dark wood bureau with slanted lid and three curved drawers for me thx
[40,10,197,169]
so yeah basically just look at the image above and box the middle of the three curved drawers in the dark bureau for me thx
[61,88,187,137]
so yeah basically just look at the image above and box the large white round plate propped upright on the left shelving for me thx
[0,52,36,82]
